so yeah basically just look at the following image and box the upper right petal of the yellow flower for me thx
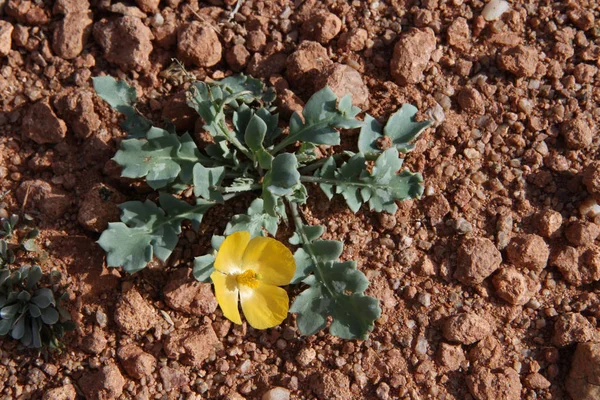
[242,236,296,286]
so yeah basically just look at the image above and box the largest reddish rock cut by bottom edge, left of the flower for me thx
[79,364,125,400]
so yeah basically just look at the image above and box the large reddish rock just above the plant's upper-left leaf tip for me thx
[93,16,154,72]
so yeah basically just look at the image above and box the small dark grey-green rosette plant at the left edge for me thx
[0,266,75,349]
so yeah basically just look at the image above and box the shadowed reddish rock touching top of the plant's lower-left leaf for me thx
[77,183,126,232]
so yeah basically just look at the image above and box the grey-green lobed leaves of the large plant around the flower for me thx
[94,71,430,338]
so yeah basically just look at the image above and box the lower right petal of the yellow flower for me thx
[240,282,290,329]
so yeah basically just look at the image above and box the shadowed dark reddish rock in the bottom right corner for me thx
[565,343,600,400]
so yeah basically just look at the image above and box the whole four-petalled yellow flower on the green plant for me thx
[210,232,296,329]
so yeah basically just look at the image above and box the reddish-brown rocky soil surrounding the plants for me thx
[0,0,600,400]
